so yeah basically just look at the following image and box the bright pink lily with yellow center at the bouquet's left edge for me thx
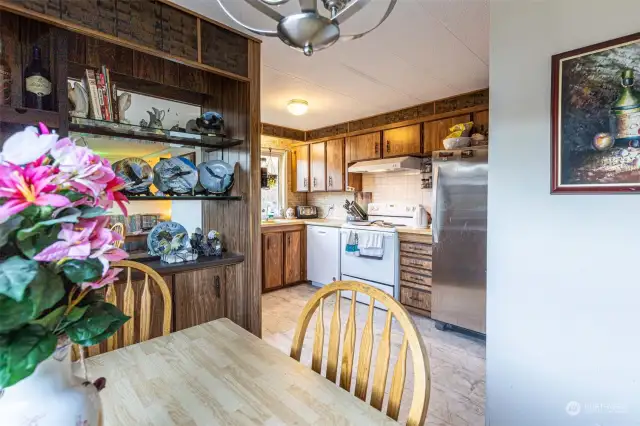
[0,159,71,223]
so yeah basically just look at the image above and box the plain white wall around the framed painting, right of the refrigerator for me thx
[487,0,640,426]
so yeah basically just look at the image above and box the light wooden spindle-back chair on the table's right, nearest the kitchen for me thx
[291,281,431,426]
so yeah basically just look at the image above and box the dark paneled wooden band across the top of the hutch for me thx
[0,0,250,81]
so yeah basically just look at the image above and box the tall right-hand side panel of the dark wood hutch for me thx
[203,41,262,336]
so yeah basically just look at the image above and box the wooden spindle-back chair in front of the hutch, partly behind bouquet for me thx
[87,260,171,356]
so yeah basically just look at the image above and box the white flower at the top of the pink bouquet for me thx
[0,127,58,166]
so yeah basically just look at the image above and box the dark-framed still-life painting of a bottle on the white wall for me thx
[551,33,640,193]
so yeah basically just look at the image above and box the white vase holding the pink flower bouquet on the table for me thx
[0,339,104,426]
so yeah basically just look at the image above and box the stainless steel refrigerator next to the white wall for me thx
[431,147,489,334]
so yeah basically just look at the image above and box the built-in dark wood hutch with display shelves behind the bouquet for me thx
[0,0,262,336]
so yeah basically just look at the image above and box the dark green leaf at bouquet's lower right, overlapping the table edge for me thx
[64,302,130,346]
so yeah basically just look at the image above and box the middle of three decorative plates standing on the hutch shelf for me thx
[153,157,198,194]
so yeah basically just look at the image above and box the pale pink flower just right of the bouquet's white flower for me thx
[51,138,115,200]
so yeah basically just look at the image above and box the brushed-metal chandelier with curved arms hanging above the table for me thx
[218,0,397,56]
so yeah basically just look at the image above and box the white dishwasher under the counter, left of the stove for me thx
[307,225,340,287]
